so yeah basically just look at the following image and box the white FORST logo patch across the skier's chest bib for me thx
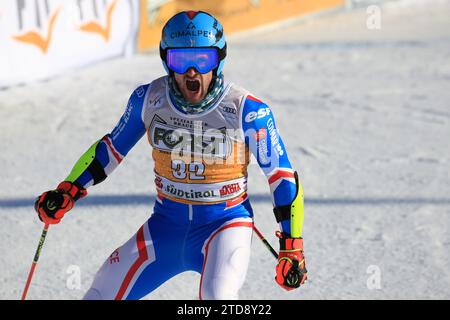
[149,121,231,159]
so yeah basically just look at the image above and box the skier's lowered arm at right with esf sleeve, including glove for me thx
[242,96,307,290]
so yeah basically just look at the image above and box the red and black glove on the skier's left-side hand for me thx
[34,181,87,224]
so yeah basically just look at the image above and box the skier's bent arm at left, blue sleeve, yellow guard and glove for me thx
[35,85,149,224]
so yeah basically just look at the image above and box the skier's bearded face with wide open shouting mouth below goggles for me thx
[175,68,212,103]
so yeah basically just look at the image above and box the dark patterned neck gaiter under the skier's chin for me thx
[168,73,224,114]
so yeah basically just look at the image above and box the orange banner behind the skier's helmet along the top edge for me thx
[138,0,345,51]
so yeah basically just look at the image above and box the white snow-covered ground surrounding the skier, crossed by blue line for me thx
[0,1,450,299]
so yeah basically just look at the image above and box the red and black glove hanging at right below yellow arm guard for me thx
[275,231,308,291]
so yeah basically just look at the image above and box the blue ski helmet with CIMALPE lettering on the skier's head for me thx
[159,11,227,75]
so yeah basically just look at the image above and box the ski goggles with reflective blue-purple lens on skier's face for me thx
[166,48,219,74]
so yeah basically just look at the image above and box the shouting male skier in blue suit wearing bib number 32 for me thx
[35,11,307,299]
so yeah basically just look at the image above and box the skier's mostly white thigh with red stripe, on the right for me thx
[200,219,252,300]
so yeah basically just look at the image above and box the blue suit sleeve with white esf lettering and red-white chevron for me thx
[242,95,297,234]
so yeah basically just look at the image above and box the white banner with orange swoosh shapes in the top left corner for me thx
[0,0,138,87]
